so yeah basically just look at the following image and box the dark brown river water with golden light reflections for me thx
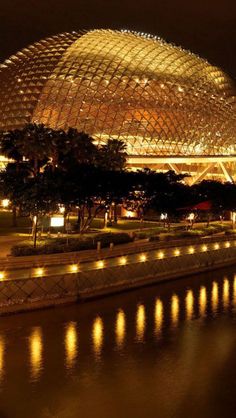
[0,267,236,418]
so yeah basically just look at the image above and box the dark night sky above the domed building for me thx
[0,0,236,79]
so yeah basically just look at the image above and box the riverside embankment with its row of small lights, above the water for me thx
[0,237,236,314]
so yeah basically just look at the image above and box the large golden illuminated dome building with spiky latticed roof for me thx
[0,30,236,182]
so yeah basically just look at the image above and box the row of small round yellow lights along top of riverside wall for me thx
[0,241,231,280]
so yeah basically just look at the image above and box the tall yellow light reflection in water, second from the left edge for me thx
[29,327,43,380]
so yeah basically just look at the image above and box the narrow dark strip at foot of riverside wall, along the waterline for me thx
[0,255,236,316]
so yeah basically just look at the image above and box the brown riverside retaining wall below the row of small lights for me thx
[0,241,236,314]
